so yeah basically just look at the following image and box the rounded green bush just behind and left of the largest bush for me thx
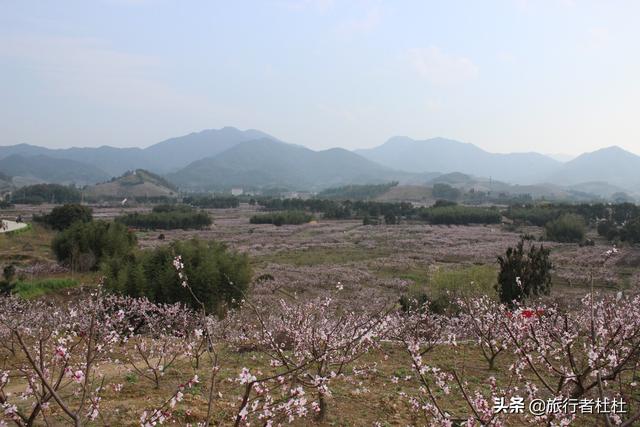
[51,221,136,271]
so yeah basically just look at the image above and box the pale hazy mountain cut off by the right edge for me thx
[549,146,640,193]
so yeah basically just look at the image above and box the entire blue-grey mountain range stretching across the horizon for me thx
[0,127,640,197]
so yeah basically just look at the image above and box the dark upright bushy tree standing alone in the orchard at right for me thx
[496,239,553,304]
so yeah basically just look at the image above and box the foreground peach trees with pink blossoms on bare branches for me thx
[0,252,640,426]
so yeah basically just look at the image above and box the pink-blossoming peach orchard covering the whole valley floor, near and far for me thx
[0,209,640,426]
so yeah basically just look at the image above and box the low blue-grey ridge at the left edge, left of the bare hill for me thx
[0,154,109,185]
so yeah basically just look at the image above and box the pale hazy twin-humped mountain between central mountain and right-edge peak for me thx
[355,136,562,183]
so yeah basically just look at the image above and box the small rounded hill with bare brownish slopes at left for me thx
[84,169,177,199]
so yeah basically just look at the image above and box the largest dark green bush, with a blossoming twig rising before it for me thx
[102,240,251,313]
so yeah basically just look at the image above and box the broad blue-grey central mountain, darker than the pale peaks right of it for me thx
[167,138,410,190]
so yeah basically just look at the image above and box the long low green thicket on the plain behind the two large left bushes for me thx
[116,204,211,230]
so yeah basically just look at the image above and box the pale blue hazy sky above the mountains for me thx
[0,0,640,155]
